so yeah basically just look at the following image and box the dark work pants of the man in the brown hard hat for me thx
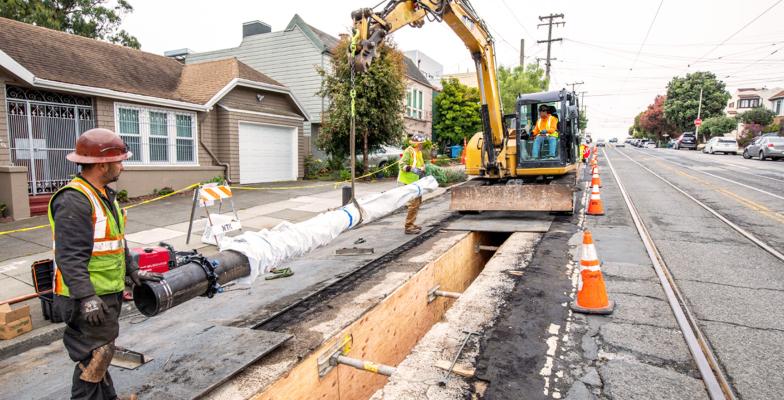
[54,292,122,400]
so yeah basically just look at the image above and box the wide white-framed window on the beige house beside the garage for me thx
[115,104,202,165]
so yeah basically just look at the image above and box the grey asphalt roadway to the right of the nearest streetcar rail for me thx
[600,147,784,399]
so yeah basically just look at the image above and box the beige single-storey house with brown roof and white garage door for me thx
[0,18,309,219]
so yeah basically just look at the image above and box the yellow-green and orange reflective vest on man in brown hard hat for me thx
[49,177,125,296]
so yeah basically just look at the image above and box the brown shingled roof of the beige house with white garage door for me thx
[0,18,308,118]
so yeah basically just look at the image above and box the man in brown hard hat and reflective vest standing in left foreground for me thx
[49,129,162,400]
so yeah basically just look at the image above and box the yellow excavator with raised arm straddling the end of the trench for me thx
[351,0,580,213]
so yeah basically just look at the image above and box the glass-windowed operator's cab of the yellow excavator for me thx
[515,89,580,175]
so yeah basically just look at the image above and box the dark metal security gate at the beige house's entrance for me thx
[6,86,95,196]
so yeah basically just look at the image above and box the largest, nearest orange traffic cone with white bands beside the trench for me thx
[570,231,615,314]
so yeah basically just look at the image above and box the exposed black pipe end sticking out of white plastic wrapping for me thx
[133,250,250,317]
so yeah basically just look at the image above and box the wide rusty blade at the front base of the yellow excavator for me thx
[449,174,578,213]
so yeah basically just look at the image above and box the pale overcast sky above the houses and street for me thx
[123,0,784,138]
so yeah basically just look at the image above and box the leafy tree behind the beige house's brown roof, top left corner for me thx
[0,0,141,49]
